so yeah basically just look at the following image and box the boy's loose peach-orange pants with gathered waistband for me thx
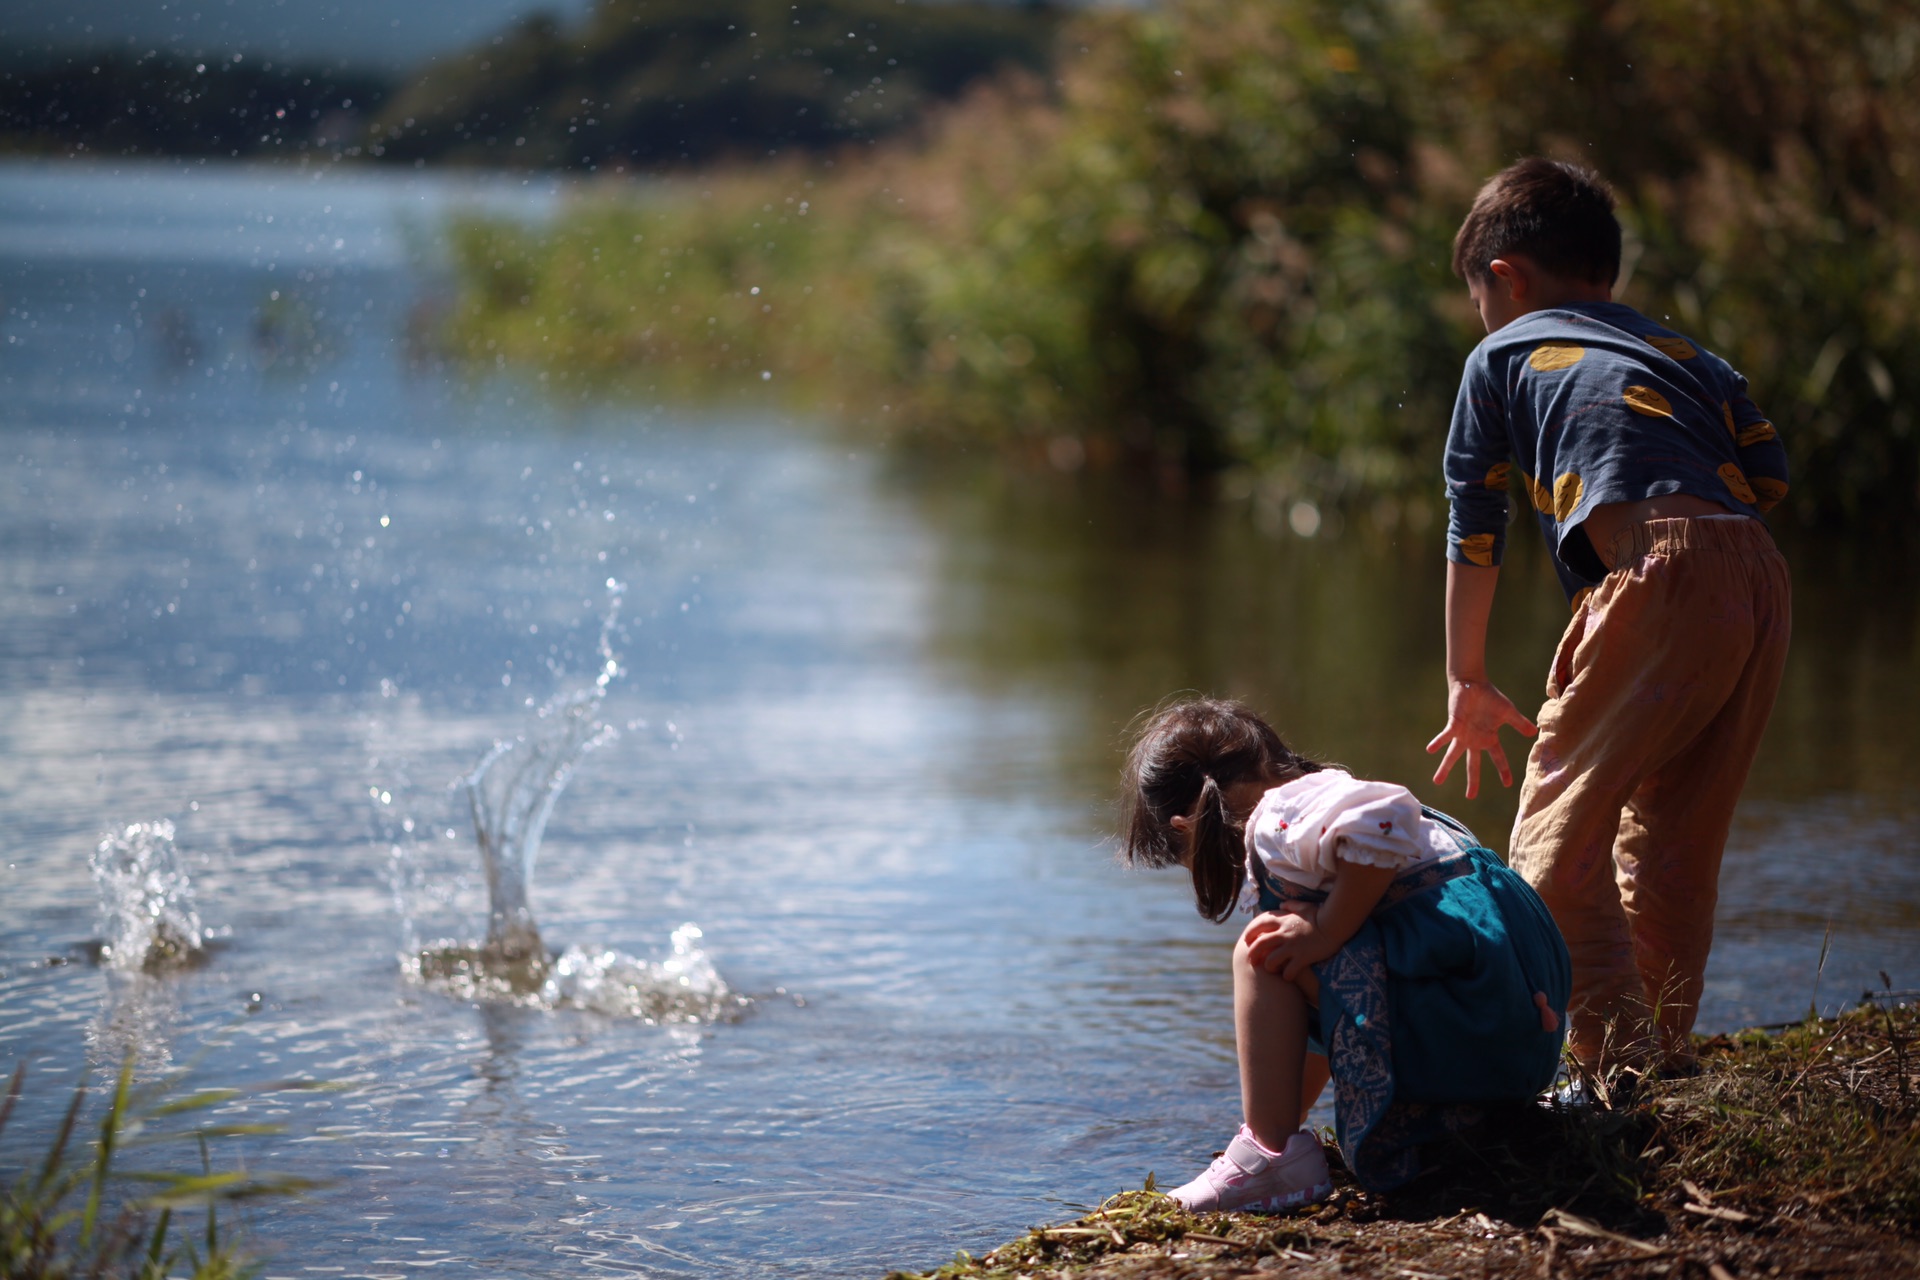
[1511,520,1791,1067]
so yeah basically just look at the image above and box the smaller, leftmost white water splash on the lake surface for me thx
[92,819,207,973]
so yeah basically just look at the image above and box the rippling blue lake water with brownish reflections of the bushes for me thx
[0,163,1920,1278]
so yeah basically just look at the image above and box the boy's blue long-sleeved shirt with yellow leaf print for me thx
[1446,301,1788,599]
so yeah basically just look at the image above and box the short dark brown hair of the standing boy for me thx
[1453,155,1620,284]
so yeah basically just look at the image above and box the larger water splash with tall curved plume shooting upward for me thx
[408,578,747,1023]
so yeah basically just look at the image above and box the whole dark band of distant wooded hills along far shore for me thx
[0,0,1058,171]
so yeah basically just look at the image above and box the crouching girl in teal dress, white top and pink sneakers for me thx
[1123,699,1571,1213]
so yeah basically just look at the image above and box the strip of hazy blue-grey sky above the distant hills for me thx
[0,0,593,71]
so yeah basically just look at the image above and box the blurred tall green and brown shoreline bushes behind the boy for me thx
[447,0,1920,528]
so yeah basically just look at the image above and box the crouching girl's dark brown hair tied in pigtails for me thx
[1121,699,1323,921]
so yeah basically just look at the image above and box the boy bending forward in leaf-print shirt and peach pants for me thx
[1427,159,1791,1069]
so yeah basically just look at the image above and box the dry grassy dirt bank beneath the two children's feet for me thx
[893,1000,1920,1280]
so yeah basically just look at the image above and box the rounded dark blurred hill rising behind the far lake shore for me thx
[357,0,1058,169]
